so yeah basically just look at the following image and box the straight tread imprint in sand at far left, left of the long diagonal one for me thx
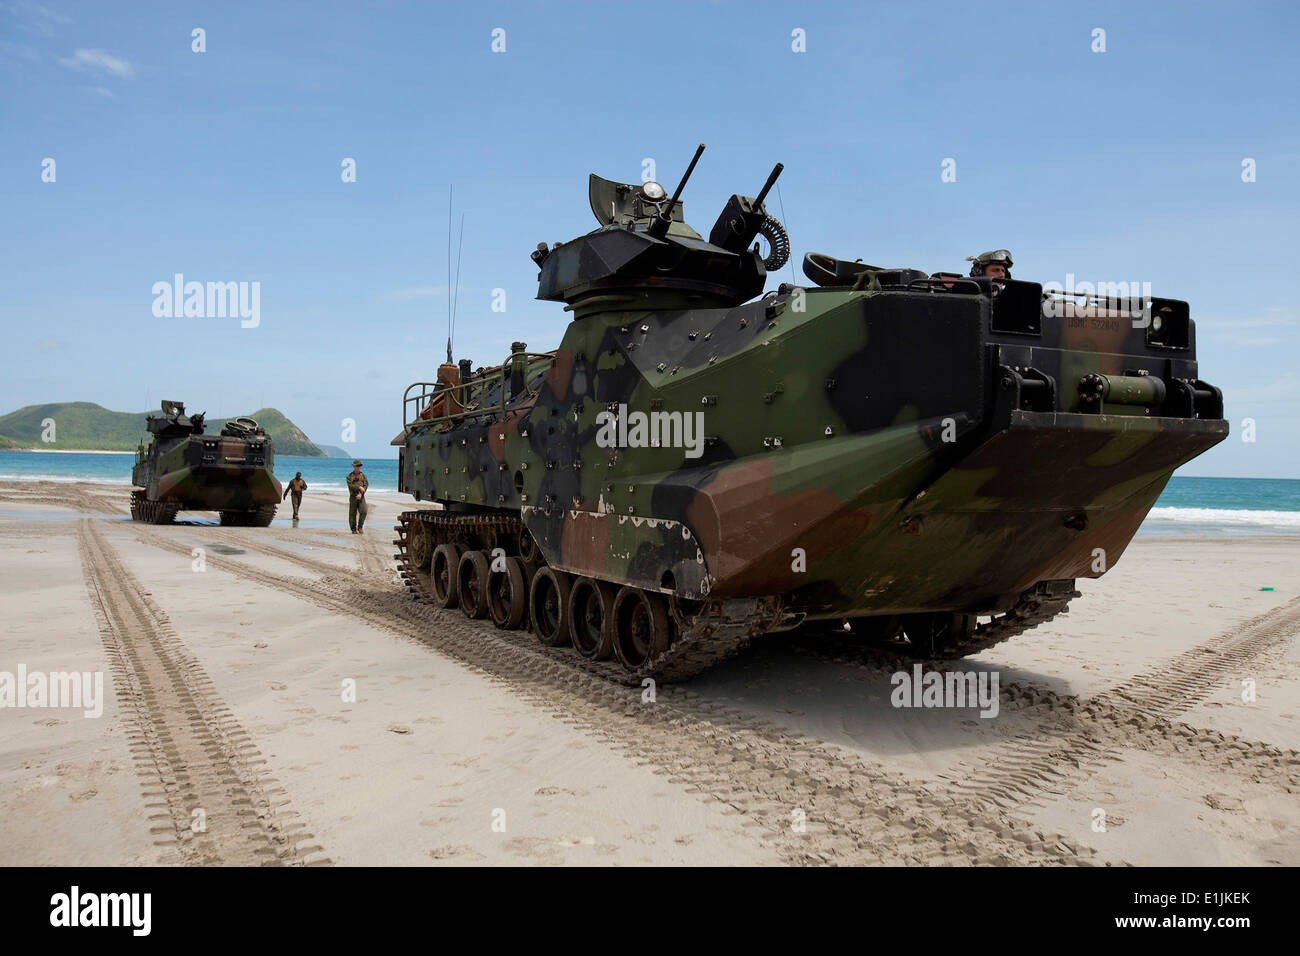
[77,519,329,866]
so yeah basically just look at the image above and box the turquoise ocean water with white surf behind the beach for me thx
[0,451,1300,535]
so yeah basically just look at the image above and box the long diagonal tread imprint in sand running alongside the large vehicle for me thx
[126,525,1093,865]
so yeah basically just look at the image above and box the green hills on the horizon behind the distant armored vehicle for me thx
[0,402,325,458]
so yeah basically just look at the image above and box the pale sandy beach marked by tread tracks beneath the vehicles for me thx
[0,481,1300,866]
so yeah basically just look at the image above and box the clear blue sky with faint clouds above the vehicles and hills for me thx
[0,0,1300,477]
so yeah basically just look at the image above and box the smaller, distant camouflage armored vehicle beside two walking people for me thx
[131,402,282,528]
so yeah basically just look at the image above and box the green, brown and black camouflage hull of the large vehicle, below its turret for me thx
[395,178,1227,629]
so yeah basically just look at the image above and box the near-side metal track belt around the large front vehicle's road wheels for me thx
[393,509,754,685]
